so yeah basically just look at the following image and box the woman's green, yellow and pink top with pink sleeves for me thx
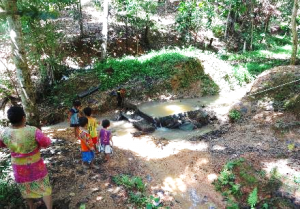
[0,126,51,183]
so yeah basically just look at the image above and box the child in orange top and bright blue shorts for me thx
[78,117,96,168]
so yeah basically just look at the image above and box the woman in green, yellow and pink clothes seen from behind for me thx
[0,106,52,209]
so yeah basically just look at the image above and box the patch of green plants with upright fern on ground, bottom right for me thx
[213,158,294,209]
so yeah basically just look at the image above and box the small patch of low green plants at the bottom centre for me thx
[112,174,168,209]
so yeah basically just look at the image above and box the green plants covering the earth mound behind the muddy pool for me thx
[95,49,219,94]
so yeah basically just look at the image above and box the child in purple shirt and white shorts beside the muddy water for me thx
[99,120,113,162]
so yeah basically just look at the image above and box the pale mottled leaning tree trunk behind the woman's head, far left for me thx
[2,0,40,127]
